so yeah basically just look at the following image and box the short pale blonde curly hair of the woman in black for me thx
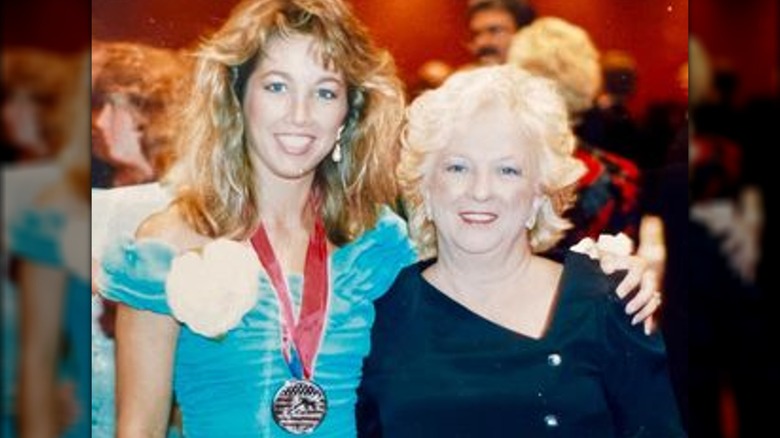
[397,65,584,259]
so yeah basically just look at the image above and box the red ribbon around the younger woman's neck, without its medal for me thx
[251,215,328,380]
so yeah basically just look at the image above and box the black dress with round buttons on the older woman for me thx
[356,253,685,438]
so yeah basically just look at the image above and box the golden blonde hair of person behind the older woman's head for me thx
[508,17,602,118]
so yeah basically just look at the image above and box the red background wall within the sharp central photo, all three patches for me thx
[92,0,688,114]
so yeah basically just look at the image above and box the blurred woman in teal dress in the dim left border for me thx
[9,48,91,437]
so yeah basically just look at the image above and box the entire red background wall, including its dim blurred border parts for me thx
[2,0,778,108]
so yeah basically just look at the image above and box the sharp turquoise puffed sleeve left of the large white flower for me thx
[97,238,176,315]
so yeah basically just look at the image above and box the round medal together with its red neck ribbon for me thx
[251,209,328,435]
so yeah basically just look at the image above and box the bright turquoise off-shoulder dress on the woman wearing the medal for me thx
[98,209,416,438]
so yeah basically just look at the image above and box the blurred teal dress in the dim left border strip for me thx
[10,208,90,437]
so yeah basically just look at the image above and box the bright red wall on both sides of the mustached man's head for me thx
[353,0,688,111]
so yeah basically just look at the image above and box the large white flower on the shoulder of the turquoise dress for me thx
[165,239,260,338]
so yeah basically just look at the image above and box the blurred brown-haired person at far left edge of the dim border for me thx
[0,47,73,436]
